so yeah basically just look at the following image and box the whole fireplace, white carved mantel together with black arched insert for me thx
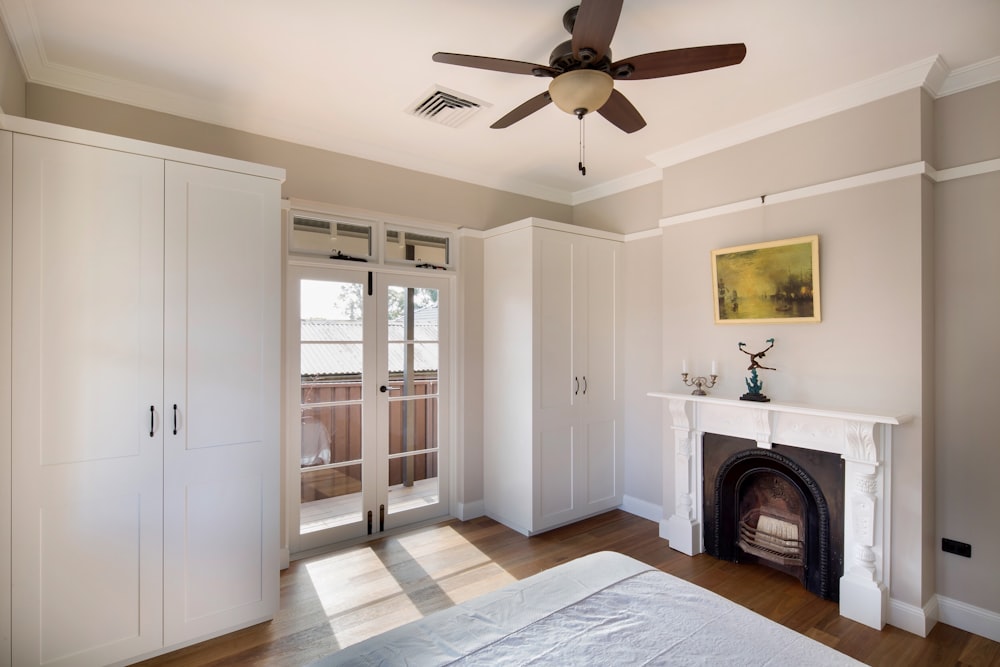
[649,392,909,630]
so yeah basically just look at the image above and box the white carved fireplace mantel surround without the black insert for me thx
[649,392,910,630]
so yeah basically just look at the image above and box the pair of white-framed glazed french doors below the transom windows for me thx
[288,266,450,553]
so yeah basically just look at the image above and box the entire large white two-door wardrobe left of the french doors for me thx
[0,117,284,667]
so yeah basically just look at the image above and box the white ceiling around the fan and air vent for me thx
[0,0,1000,203]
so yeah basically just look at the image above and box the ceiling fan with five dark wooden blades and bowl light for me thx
[433,0,747,133]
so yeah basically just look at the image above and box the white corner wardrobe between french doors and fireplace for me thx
[483,219,624,535]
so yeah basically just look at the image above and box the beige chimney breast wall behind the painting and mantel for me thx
[662,90,935,609]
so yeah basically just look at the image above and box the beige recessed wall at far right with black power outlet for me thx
[934,83,1000,614]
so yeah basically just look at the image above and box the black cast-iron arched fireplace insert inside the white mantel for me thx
[702,433,844,601]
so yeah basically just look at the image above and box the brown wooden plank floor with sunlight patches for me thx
[142,511,1000,667]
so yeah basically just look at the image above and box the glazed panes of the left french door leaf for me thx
[299,280,365,534]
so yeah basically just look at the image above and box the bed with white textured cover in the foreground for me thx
[314,551,863,667]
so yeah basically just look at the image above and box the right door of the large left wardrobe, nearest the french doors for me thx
[164,162,281,644]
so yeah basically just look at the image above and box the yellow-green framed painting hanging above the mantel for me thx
[712,235,820,324]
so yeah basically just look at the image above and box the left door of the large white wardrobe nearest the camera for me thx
[11,135,163,667]
